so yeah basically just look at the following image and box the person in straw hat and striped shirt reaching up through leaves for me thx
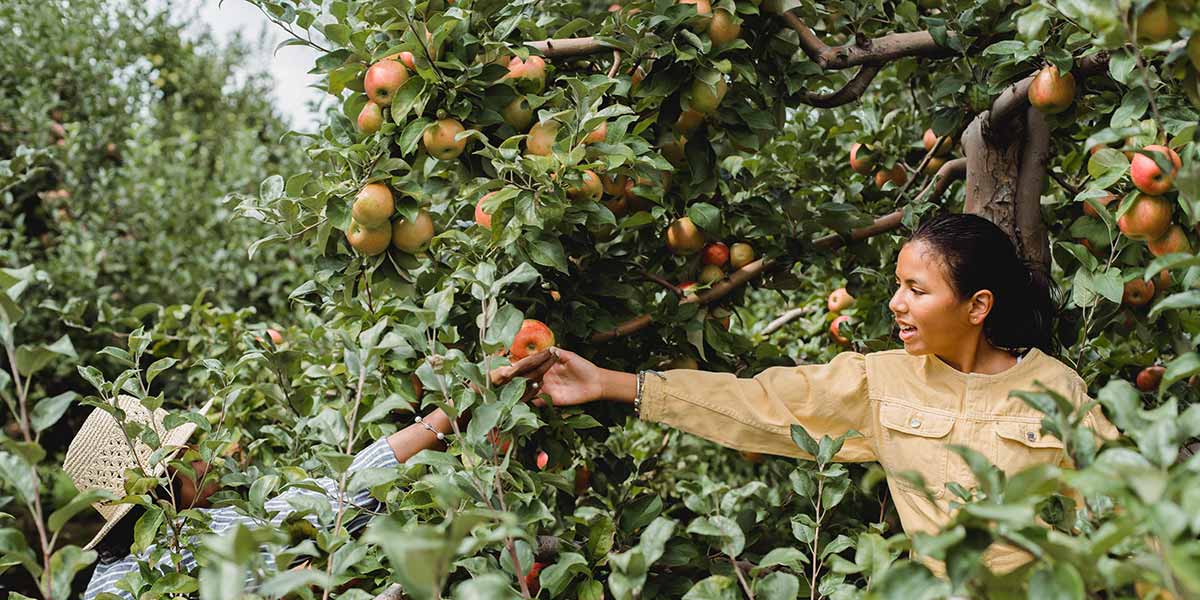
[77,349,554,600]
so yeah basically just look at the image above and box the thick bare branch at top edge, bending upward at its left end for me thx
[782,12,954,68]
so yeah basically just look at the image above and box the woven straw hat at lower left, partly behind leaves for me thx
[62,395,212,550]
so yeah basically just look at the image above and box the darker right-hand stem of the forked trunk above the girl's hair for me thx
[1015,107,1050,274]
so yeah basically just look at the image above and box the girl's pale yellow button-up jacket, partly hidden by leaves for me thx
[641,348,1118,575]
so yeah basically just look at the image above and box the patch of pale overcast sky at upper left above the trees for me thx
[182,0,324,131]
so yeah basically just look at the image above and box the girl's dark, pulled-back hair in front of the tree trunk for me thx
[908,214,1057,355]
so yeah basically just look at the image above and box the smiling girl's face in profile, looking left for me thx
[888,241,982,356]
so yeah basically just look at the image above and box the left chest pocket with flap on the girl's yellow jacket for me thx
[880,402,954,498]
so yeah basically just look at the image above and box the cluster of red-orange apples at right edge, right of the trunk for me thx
[1084,144,1192,306]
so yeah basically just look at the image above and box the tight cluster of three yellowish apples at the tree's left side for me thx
[346,184,433,256]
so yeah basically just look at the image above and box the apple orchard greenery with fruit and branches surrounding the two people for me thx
[0,0,1200,599]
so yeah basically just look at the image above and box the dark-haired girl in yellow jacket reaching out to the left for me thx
[536,215,1118,575]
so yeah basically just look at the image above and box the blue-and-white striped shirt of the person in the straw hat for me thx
[83,438,400,600]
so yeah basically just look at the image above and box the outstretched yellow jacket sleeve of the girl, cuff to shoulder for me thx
[640,352,876,462]
